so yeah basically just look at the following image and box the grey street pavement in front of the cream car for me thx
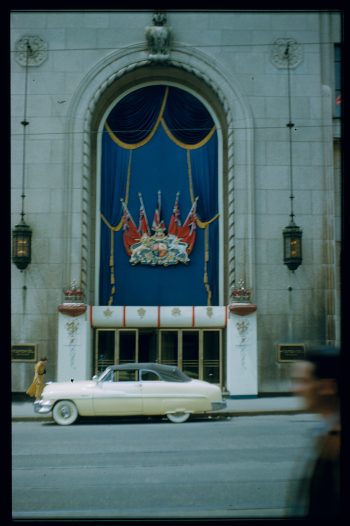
[11,413,318,524]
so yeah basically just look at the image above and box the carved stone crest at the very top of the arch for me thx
[145,11,171,62]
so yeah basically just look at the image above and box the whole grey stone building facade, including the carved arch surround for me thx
[11,10,342,395]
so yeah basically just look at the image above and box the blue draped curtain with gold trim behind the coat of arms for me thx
[100,85,220,305]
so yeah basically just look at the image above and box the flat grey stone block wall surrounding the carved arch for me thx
[11,11,341,392]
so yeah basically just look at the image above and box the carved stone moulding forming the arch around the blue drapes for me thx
[64,45,255,301]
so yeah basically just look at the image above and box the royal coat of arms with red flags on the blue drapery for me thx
[122,191,198,267]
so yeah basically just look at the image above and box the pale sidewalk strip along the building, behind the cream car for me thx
[12,396,304,422]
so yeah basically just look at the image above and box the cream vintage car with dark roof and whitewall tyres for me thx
[34,363,226,425]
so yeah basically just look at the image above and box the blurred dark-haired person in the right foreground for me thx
[287,347,341,520]
